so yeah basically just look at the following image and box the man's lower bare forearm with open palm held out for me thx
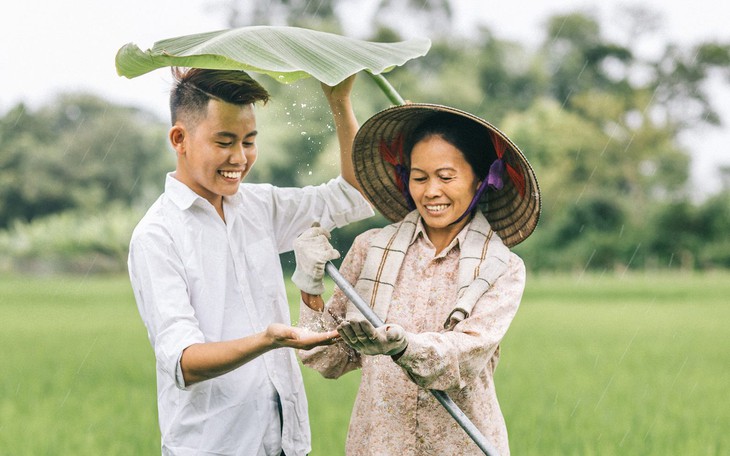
[180,323,338,386]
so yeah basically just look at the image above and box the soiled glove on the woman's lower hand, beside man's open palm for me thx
[337,319,408,355]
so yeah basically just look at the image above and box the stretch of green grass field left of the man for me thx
[0,278,159,455]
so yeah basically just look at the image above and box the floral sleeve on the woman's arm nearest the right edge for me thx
[396,254,525,391]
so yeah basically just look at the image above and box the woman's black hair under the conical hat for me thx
[403,112,497,180]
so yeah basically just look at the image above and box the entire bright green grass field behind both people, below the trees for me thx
[0,273,730,456]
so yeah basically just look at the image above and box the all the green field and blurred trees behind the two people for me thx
[0,0,730,455]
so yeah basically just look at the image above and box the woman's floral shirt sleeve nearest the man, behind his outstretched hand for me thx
[298,230,378,378]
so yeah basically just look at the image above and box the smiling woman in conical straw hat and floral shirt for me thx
[293,104,540,455]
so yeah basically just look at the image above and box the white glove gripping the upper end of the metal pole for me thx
[291,222,340,295]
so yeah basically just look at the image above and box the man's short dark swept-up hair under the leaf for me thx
[170,67,269,125]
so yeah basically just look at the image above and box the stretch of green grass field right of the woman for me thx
[495,275,730,455]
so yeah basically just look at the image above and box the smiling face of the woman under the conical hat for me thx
[408,135,480,244]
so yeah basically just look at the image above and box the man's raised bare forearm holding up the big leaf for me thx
[322,75,361,190]
